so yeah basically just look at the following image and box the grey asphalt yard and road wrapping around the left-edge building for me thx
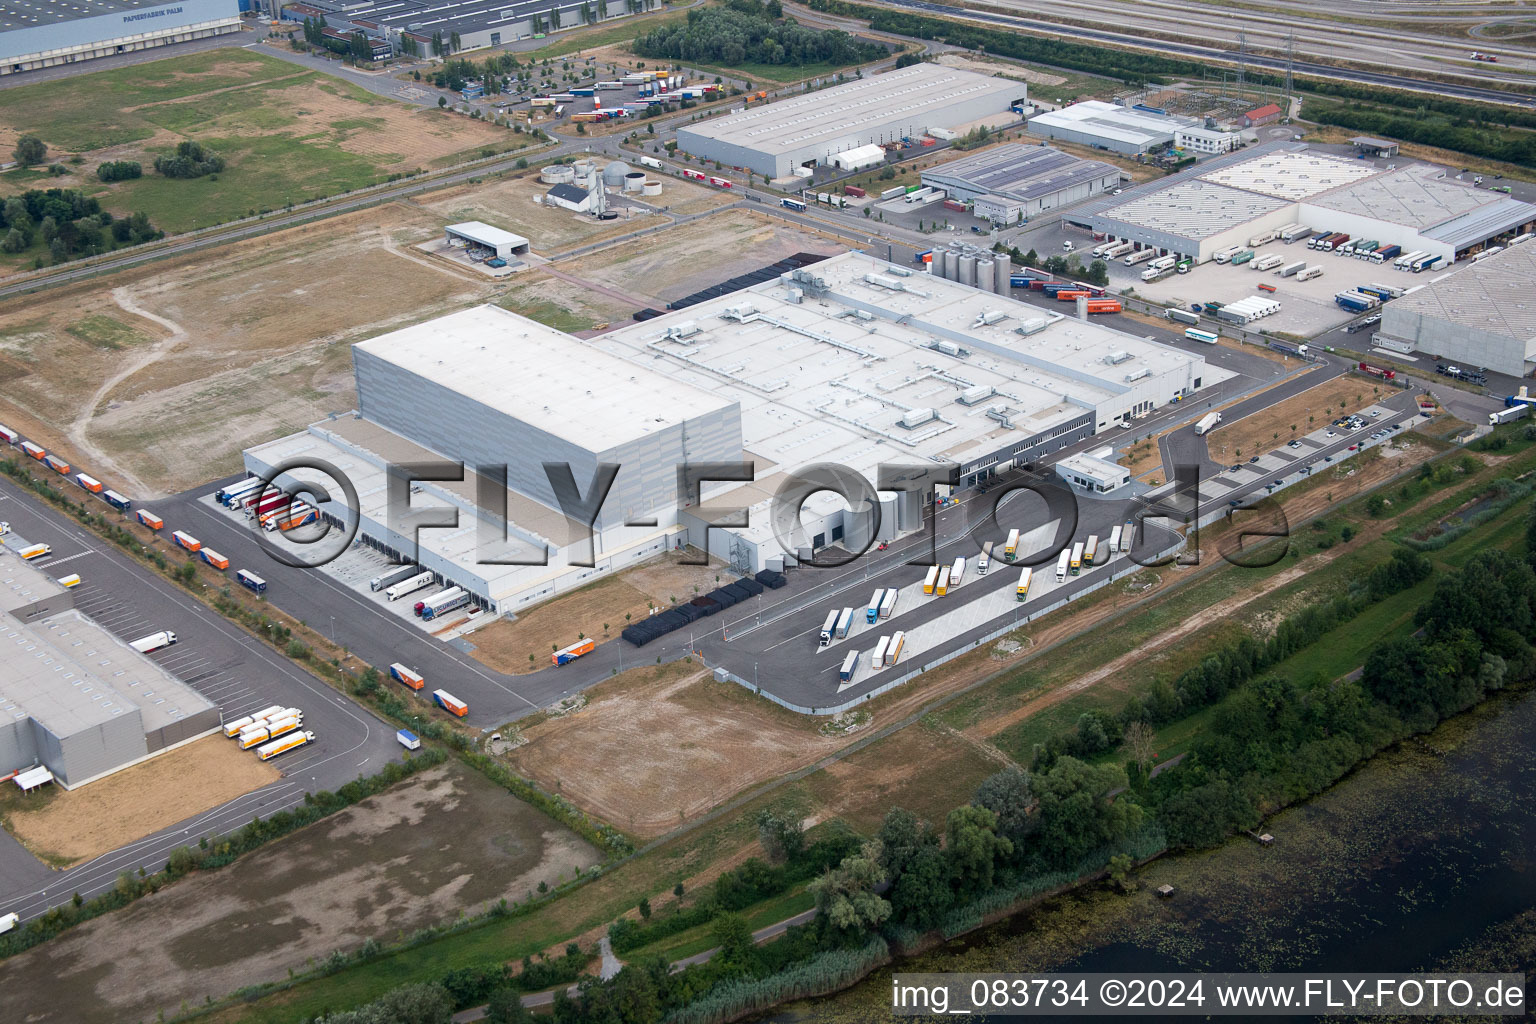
[0,477,401,918]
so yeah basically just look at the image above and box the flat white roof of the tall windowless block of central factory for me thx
[356,306,730,451]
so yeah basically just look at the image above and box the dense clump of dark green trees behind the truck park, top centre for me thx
[634,0,889,68]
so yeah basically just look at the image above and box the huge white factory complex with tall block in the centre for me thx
[246,252,1230,614]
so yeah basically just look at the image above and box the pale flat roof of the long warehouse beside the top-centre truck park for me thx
[679,64,1026,154]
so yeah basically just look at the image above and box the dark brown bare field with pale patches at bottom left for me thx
[0,763,601,1024]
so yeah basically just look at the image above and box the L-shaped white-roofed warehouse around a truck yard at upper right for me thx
[1069,143,1536,270]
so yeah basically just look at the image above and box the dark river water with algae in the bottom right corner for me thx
[765,692,1536,1024]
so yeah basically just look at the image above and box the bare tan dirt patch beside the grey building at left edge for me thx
[0,735,283,867]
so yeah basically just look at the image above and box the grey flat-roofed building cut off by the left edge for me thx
[0,547,220,789]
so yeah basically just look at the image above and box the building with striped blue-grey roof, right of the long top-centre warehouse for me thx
[922,143,1120,224]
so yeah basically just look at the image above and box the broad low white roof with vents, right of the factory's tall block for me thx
[588,252,1223,481]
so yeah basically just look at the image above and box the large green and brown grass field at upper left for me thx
[0,49,533,239]
